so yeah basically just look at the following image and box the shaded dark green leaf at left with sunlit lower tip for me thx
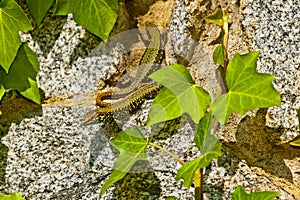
[0,43,41,104]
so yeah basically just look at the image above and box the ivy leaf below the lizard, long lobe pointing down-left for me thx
[100,128,148,196]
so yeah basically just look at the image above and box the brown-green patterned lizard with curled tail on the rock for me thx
[81,27,161,125]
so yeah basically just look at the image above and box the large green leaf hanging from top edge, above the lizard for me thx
[55,0,118,40]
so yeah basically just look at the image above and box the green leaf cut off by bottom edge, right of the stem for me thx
[231,186,280,200]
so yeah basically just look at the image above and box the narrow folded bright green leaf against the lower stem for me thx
[176,112,221,189]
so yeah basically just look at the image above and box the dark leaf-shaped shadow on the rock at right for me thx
[223,109,300,183]
